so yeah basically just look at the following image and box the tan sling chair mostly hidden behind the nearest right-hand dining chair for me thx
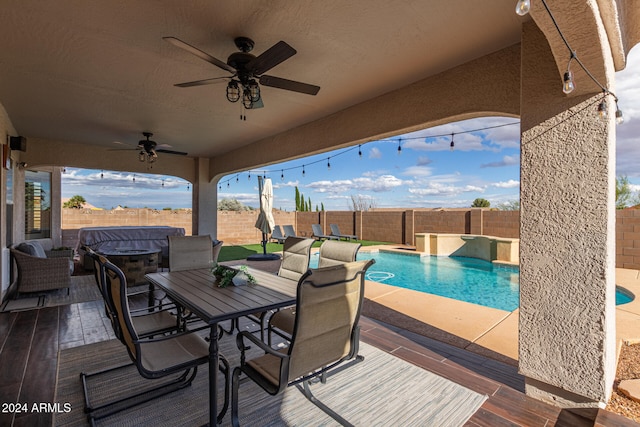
[267,240,361,345]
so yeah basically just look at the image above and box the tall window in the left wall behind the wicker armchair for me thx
[24,171,51,240]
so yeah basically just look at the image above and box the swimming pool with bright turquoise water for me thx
[309,251,633,311]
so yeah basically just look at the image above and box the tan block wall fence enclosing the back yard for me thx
[62,208,640,270]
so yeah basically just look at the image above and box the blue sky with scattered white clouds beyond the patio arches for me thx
[62,47,640,211]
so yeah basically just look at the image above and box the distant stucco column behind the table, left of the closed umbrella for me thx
[191,158,218,239]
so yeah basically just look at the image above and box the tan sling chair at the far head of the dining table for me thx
[167,234,223,271]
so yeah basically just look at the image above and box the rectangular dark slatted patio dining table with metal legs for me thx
[145,267,297,426]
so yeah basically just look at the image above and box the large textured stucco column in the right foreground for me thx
[519,24,616,407]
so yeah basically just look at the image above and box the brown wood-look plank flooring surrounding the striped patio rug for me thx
[0,302,638,427]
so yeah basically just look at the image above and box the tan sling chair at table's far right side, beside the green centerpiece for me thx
[238,236,314,341]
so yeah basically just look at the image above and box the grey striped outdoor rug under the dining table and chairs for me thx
[54,335,486,426]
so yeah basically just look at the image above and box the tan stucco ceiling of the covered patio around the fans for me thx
[0,0,530,158]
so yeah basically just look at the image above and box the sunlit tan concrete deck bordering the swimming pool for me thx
[360,247,640,365]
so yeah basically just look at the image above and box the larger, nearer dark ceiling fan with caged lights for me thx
[163,37,320,109]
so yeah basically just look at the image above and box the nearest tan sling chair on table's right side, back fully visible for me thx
[231,260,375,426]
